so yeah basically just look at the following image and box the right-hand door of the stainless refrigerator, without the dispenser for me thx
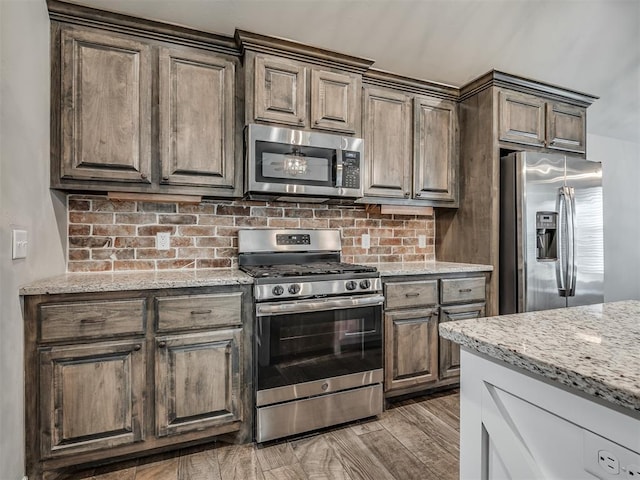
[566,157,604,306]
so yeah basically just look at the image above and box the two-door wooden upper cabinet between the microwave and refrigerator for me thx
[362,71,459,207]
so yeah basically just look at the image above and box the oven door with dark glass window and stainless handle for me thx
[256,295,384,407]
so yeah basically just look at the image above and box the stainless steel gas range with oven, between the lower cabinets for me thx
[238,229,384,442]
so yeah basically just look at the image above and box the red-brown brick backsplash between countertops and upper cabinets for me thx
[67,194,435,272]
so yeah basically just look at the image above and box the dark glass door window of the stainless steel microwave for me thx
[255,141,336,187]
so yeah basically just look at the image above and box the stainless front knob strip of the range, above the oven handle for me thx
[254,277,382,301]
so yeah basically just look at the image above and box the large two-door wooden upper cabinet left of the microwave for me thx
[48,1,242,197]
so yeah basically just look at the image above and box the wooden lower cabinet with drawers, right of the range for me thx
[383,272,487,398]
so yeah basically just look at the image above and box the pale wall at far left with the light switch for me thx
[0,0,66,480]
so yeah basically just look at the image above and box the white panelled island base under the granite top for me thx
[460,347,640,480]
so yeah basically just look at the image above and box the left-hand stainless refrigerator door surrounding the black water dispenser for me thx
[516,152,567,312]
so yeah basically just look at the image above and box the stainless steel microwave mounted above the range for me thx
[245,124,364,201]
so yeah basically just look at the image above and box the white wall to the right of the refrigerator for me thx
[587,135,640,302]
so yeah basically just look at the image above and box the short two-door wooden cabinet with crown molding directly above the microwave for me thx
[236,30,373,136]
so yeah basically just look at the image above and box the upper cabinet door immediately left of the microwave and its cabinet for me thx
[159,48,235,191]
